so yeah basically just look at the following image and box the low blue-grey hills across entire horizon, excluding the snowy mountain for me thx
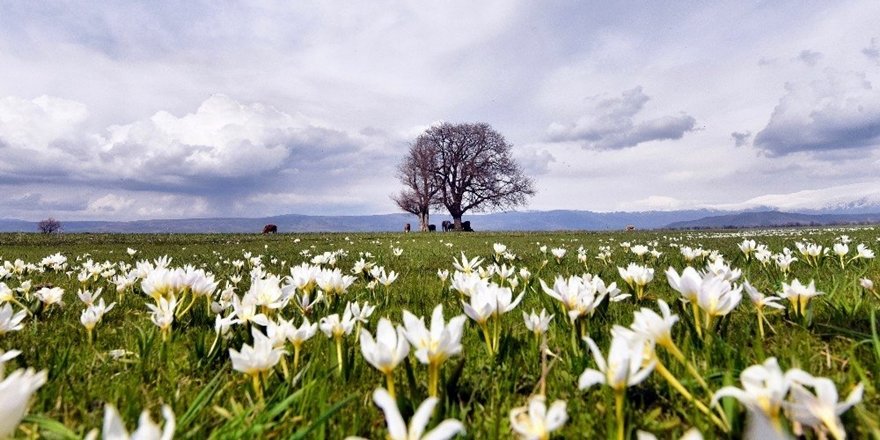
[0,208,880,233]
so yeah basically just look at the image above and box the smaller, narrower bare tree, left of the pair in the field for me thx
[391,140,439,232]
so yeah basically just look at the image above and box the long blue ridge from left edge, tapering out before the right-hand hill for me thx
[0,209,719,233]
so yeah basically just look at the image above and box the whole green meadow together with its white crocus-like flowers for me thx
[0,227,880,439]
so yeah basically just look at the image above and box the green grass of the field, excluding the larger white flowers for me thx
[0,228,880,439]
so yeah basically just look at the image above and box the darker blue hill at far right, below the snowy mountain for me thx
[666,211,880,229]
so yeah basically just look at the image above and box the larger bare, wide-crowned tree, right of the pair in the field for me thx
[404,123,535,230]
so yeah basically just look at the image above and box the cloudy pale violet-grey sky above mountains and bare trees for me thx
[0,0,880,220]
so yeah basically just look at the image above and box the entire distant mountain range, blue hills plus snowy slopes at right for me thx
[0,183,880,233]
